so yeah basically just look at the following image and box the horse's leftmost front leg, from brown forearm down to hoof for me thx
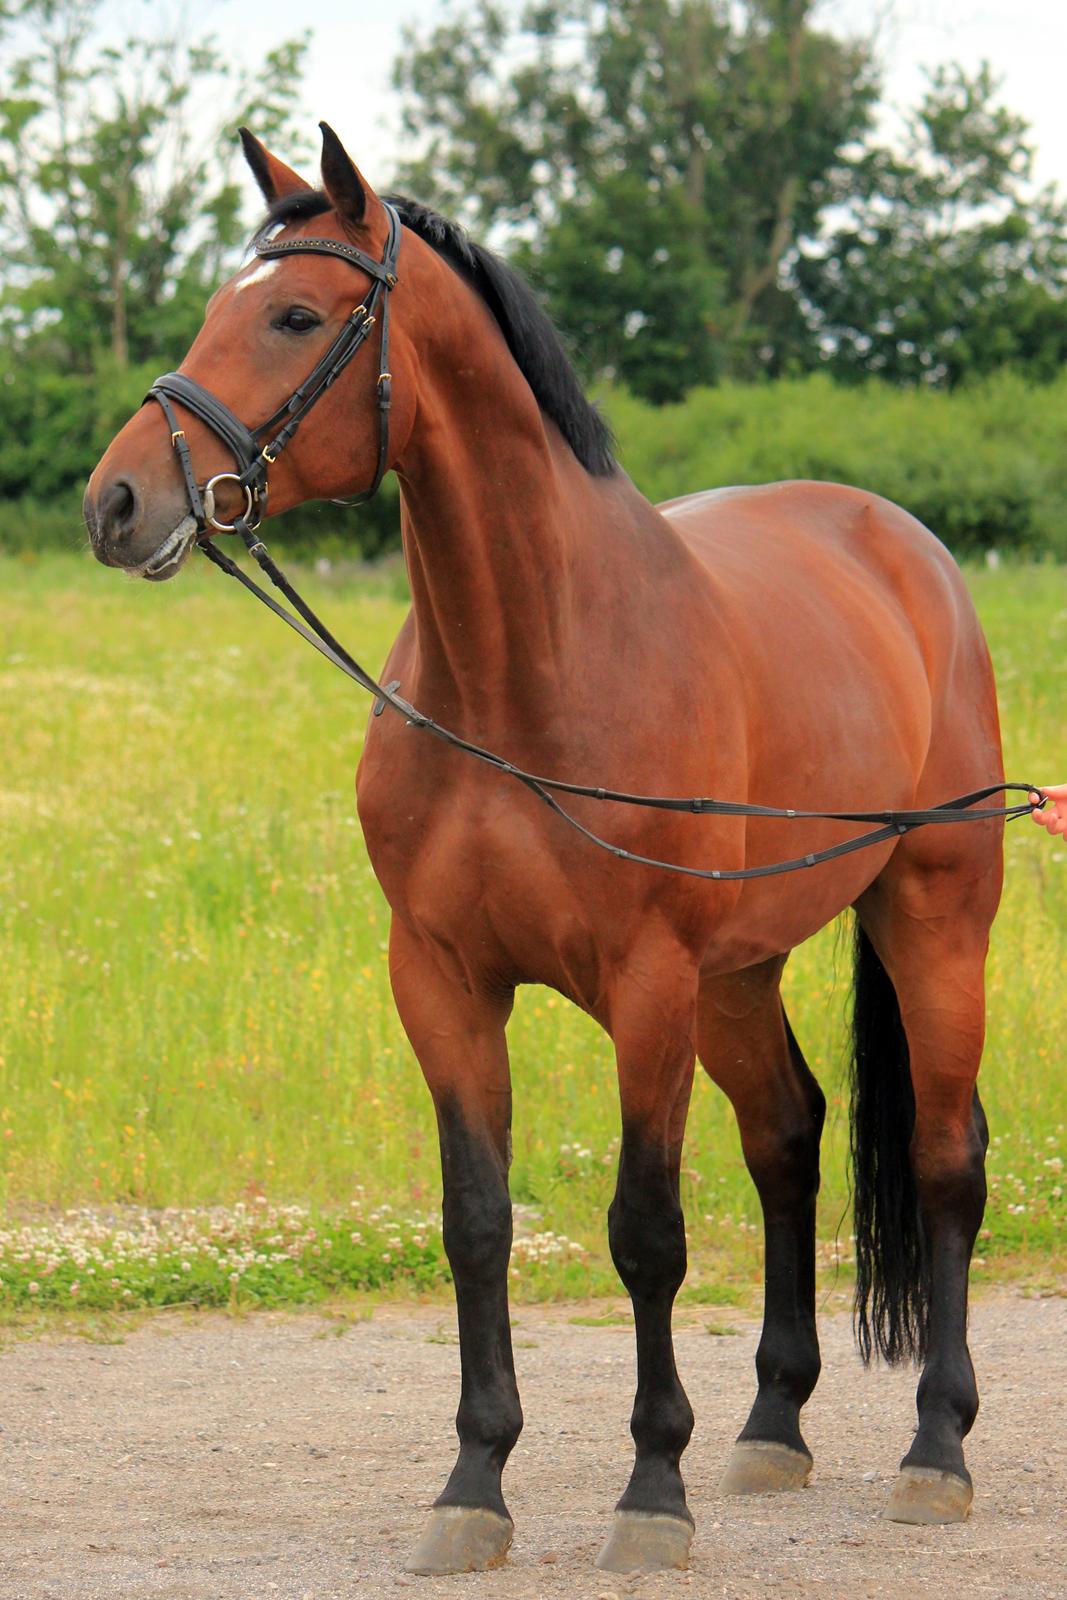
[390,920,523,1573]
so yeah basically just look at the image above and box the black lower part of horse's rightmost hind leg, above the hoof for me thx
[901,1096,987,1483]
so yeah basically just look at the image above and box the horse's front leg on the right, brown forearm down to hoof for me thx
[597,952,696,1573]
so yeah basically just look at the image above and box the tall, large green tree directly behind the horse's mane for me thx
[394,0,877,400]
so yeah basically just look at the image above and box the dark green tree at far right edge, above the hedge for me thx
[795,66,1067,386]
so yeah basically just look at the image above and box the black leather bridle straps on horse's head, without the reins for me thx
[144,203,400,549]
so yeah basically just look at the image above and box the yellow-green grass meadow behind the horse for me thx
[0,555,1067,1301]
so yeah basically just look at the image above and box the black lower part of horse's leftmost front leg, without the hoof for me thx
[437,1106,523,1517]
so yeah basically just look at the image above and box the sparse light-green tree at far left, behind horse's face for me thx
[0,0,306,373]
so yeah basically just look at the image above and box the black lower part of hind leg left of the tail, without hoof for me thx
[739,1022,825,1453]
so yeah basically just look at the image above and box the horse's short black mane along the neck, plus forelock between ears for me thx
[254,189,614,477]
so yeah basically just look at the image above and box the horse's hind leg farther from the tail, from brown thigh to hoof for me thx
[697,960,825,1494]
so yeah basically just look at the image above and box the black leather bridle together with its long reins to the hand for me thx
[146,203,1048,883]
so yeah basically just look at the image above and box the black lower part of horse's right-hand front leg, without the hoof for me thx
[608,1131,693,1522]
